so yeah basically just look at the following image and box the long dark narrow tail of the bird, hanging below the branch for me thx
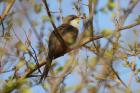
[39,57,52,83]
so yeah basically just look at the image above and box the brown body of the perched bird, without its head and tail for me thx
[48,24,78,59]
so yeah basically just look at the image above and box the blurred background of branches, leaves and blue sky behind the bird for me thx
[0,0,140,93]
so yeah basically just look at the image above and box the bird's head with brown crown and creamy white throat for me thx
[63,15,82,28]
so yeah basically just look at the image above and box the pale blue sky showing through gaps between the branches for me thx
[0,0,140,93]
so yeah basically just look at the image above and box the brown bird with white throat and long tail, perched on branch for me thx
[40,15,82,82]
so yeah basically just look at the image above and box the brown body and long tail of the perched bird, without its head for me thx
[40,24,78,82]
